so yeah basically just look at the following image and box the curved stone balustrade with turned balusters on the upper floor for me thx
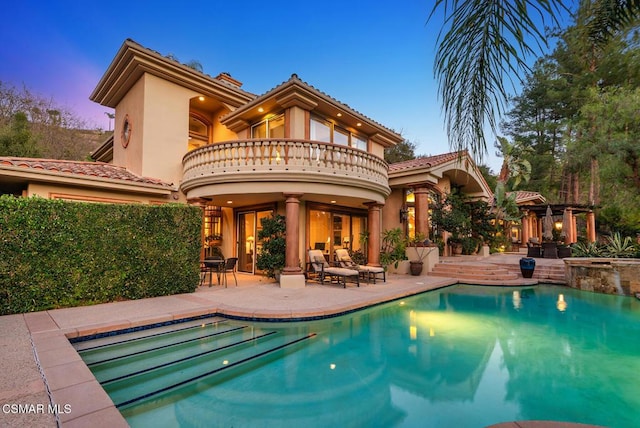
[182,139,390,196]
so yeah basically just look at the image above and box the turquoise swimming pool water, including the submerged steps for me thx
[74,286,640,428]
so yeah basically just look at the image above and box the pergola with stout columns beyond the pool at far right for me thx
[520,204,596,246]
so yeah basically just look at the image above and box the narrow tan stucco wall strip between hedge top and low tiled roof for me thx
[26,183,174,204]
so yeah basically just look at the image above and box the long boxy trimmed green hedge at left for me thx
[0,196,202,315]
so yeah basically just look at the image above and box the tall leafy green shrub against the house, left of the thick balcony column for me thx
[256,214,286,280]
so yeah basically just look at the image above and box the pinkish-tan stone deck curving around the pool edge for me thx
[0,255,600,428]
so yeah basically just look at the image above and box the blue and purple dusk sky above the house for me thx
[0,0,520,172]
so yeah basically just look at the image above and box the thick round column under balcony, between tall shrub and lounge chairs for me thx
[280,193,305,288]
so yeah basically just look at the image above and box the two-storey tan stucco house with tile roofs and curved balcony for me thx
[0,40,491,287]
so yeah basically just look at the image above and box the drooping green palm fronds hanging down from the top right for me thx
[429,0,640,161]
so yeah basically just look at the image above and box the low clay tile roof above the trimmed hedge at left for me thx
[0,156,173,188]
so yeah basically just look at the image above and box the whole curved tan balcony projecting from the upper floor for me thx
[181,139,391,202]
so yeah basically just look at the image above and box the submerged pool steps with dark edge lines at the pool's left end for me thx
[79,320,315,407]
